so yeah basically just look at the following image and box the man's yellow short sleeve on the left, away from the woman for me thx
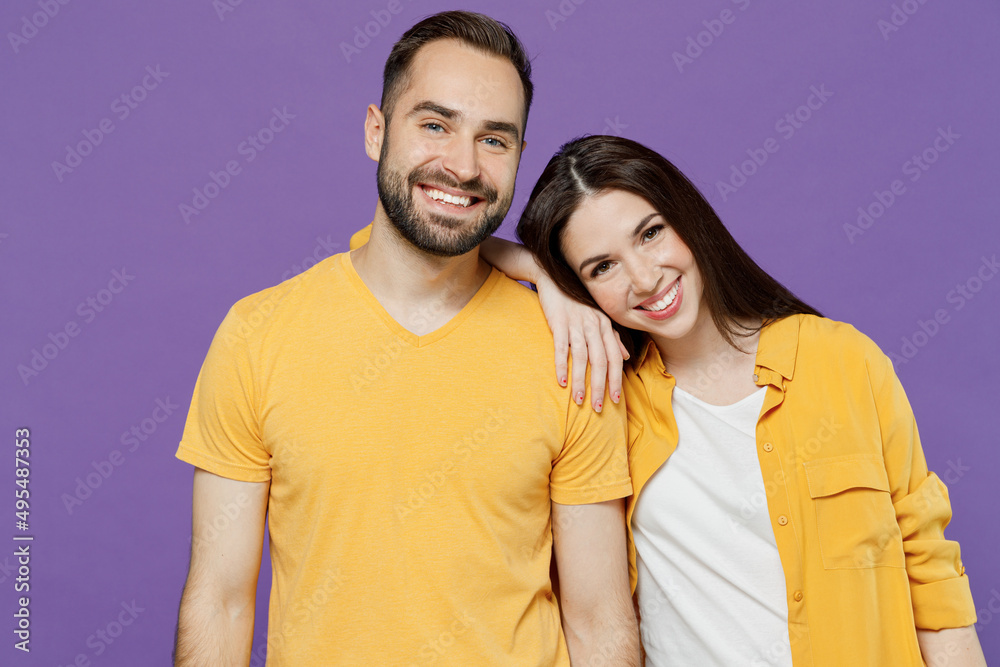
[176,307,271,482]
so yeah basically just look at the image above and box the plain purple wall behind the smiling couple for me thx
[0,0,1000,666]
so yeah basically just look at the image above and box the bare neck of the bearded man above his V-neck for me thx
[351,204,491,335]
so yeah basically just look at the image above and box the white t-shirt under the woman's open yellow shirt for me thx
[632,387,792,667]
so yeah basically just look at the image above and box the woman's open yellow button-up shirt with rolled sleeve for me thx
[626,315,976,667]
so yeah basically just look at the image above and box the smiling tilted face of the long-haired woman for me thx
[561,190,711,339]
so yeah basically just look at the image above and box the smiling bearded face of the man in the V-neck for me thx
[369,39,524,257]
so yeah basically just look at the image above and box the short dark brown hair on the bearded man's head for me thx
[379,11,534,134]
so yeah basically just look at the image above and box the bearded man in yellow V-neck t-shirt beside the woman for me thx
[176,12,638,666]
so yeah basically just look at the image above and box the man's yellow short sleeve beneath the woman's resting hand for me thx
[549,370,632,505]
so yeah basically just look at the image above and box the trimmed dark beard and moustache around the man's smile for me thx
[376,135,514,257]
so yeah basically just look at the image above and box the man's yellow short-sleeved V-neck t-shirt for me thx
[177,253,631,667]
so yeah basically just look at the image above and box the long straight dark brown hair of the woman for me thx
[517,135,820,354]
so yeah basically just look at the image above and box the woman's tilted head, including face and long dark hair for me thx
[517,135,818,360]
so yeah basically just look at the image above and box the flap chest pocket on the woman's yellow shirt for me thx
[803,454,905,570]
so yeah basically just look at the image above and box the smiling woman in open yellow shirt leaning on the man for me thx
[484,136,985,666]
